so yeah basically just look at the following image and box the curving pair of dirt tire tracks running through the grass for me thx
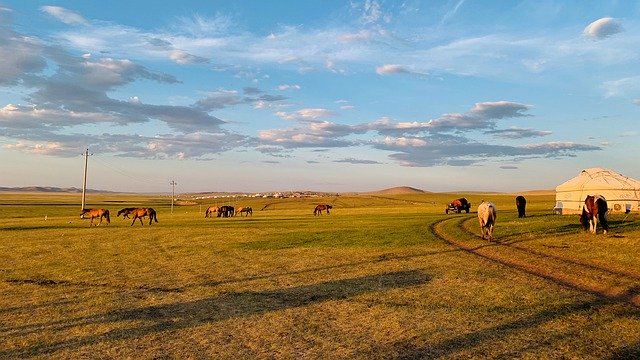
[430,217,640,308]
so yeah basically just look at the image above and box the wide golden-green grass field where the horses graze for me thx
[0,193,640,359]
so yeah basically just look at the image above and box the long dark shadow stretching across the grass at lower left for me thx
[0,270,431,358]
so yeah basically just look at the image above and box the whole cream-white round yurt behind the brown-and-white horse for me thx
[554,168,640,215]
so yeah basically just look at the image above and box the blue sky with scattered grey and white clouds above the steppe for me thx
[0,0,640,193]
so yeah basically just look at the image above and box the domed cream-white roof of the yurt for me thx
[556,168,640,191]
